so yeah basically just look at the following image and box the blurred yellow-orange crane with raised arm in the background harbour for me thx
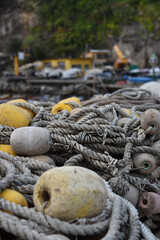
[109,35,130,69]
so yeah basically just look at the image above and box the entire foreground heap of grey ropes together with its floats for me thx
[0,88,160,240]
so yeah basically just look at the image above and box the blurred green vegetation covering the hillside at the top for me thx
[3,0,160,59]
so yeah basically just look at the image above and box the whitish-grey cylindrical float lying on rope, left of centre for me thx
[10,127,50,156]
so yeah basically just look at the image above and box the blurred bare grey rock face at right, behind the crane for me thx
[118,23,160,68]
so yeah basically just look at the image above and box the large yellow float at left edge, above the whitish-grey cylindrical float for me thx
[0,103,31,128]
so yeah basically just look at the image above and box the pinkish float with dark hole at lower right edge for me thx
[139,192,160,215]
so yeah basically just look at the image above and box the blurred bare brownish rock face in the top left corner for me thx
[0,0,37,53]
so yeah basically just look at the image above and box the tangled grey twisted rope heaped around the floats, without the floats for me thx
[0,89,160,240]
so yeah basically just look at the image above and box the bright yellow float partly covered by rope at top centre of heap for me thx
[51,97,81,114]
